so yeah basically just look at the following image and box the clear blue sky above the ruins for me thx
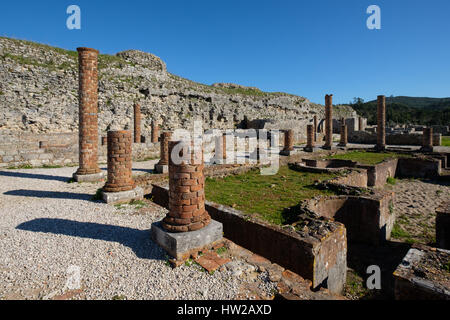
[0,0,450,104]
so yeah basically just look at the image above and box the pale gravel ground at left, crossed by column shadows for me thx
[0,162,273,299]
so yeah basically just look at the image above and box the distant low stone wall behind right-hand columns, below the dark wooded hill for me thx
[348,131,442,146]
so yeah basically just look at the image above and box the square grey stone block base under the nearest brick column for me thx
[151,220,223,260]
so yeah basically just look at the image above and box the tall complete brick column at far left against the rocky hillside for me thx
[75,48,101,175]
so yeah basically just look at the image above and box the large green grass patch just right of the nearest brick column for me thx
[205,166,336,224]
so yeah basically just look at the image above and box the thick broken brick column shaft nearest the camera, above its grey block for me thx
[162,141,211,232]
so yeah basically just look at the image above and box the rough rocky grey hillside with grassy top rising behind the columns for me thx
[0,38,355,133]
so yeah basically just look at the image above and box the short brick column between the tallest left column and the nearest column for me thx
[103,131,135,192]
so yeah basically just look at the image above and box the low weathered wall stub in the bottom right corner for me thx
[394,245,450,300]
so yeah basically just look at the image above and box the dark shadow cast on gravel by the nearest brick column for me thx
[16,218,165,260]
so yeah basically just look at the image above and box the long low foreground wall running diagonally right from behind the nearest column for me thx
[152,185,347,293]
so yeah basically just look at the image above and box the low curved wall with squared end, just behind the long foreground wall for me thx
[305,191,395,245]
